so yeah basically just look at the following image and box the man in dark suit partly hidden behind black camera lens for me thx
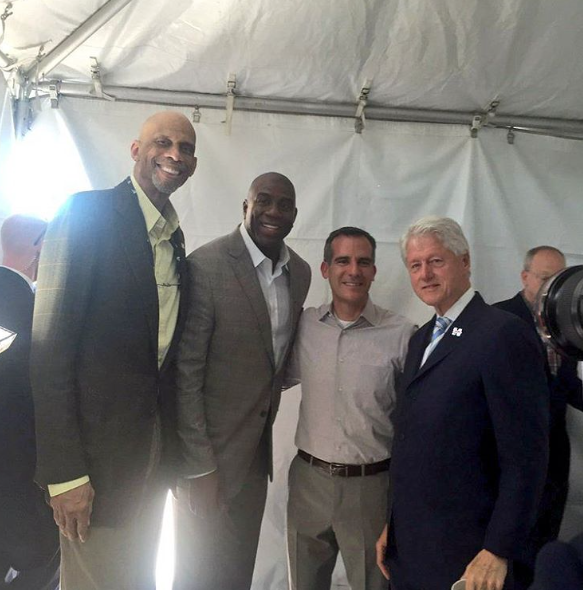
[494,246,583,586]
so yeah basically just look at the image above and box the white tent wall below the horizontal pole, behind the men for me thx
[0,98,583,590]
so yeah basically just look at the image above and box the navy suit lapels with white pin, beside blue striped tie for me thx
[406,293,486,387]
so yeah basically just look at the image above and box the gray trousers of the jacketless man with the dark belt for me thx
[287,456,389,590]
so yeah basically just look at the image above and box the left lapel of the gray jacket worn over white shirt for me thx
[228,228,275,368]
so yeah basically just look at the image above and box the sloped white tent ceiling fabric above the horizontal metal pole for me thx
[0,0,583,119]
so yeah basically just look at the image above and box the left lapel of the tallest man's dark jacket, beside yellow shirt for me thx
[113,178,159,363]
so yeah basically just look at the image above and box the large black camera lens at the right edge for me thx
[534,266,583,360]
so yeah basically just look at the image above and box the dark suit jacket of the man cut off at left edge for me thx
[0,268,59,576]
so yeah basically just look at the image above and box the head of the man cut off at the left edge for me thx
[0,215,47,281]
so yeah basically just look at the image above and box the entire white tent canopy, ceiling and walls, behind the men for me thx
[0,0,583,590]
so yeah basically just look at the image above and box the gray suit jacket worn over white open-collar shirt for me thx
[177,229,311,498]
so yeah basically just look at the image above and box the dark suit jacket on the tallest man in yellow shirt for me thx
[31,178,185,525]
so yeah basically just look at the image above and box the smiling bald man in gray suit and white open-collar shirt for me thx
[175,172,310,590]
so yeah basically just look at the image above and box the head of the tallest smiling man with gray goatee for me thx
[131,111,196,211]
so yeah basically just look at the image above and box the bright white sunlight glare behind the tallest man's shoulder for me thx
[0,119,91,220]
